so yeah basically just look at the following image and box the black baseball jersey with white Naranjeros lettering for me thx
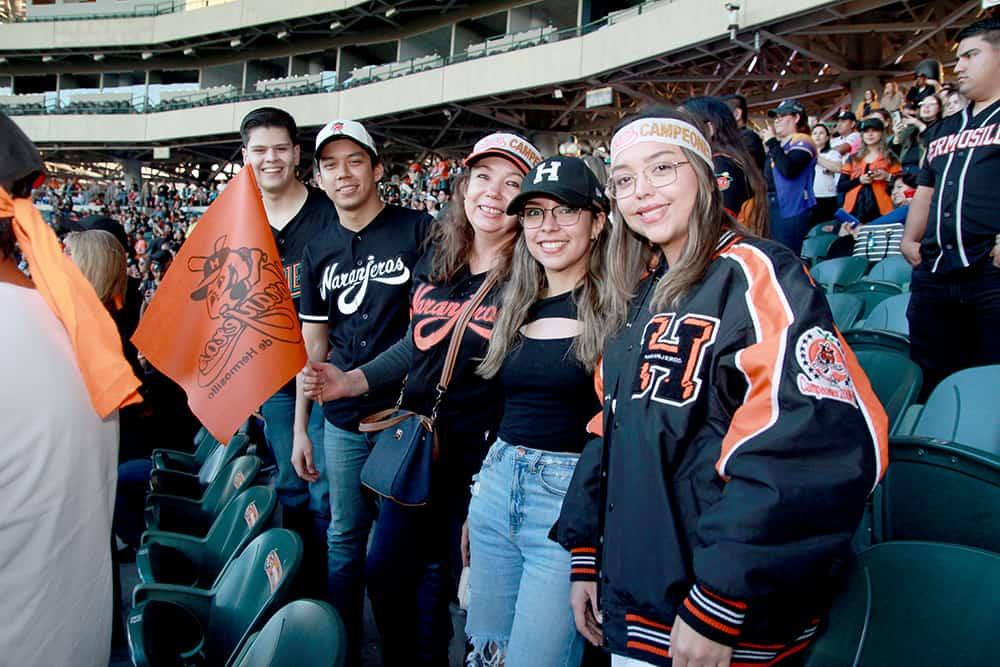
[299,205,432,431]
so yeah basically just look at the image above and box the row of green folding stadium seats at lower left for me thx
[128,429,345,667]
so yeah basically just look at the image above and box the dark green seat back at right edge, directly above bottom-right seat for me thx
[872,436,1000,552]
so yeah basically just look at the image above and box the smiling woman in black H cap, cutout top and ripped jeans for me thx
[466,157,614,667]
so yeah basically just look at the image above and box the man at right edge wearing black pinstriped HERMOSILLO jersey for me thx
[900,18,1000,393]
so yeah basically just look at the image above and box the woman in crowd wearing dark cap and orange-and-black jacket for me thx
[837,118,902,222]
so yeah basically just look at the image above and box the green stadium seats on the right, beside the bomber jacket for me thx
[802,226,1000,667]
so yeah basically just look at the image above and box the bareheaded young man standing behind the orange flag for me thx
[240,107,336,595]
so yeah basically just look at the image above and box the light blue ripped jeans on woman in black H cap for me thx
[465,440,583,667]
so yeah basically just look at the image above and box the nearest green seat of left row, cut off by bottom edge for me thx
[228,600,347,667]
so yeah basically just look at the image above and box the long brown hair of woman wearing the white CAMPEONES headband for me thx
[604,106,743,324]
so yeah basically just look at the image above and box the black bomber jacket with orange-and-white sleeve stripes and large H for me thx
[553,233,888,665]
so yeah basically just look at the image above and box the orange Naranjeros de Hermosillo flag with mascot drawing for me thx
[132,167,306,442]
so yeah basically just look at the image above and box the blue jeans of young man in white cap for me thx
[323,421,375,665]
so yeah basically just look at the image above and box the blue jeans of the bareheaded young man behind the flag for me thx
[261,392,330,517]
